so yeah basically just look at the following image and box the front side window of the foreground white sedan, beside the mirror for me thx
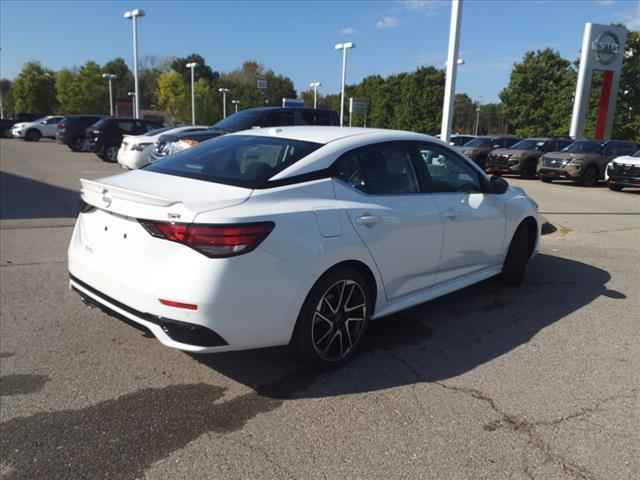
[417,144,482,193]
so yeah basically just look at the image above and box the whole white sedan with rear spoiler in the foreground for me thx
[68,127,540,368]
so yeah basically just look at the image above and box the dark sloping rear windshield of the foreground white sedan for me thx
[144,135,322,188]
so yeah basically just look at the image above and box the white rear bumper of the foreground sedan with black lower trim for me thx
[68,218,314,353]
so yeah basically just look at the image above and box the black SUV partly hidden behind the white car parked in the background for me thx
[85,118,162,162]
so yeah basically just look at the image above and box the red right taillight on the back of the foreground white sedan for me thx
[140,220,275,258]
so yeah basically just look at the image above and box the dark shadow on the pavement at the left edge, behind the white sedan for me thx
[0,171,78,220]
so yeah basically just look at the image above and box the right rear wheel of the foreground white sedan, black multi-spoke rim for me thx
[291,268,373,370]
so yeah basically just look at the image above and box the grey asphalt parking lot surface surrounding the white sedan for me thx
[0,139,640,480]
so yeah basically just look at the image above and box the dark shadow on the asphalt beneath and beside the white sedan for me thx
[192,254,626,399]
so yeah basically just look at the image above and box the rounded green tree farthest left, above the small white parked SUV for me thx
[11,61,58,114]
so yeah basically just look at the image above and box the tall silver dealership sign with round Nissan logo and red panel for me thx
[569,23,627,140]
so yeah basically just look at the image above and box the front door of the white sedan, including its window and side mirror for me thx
[416,142,506,283]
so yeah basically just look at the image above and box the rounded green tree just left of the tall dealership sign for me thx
[499,48,576,136]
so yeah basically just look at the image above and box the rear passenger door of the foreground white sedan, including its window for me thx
[334,142,443,300]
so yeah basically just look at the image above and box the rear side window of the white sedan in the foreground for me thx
[334,143,420,195]
